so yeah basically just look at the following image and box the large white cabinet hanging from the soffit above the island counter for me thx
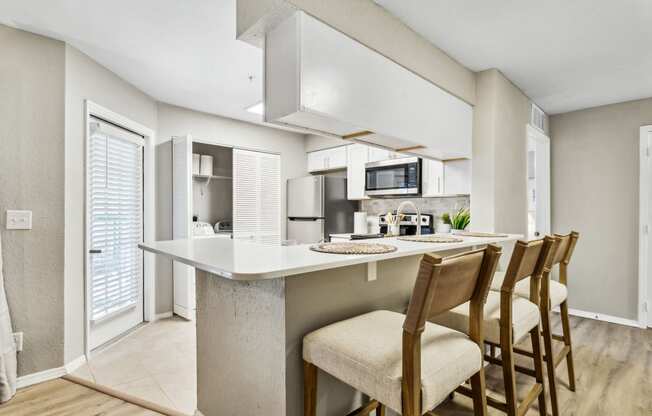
[265,12,473,160]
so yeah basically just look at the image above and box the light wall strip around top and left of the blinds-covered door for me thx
[64,45,156,362]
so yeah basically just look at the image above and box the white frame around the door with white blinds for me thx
[84,100,156,360]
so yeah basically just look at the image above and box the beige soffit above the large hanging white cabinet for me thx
[237,0,476,104]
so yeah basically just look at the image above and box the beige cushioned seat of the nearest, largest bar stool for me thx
[303,311,482,413]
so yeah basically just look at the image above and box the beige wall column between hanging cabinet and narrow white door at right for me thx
[471,69,530,235]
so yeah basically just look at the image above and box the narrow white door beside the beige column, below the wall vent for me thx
[527,126,551,238]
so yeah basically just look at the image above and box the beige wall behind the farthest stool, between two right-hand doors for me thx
[550,99,652,319]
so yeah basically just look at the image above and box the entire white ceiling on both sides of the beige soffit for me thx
[5,0,652,118]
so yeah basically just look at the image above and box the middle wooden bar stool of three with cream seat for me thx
[431,237,558,416]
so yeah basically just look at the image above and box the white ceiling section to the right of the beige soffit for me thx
[375,0,652,114]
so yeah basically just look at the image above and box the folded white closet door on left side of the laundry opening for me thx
[172,136,196,320]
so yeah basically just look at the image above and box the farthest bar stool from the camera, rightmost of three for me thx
[491,231,580,416]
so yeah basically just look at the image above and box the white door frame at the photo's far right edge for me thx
[638,125,652,328]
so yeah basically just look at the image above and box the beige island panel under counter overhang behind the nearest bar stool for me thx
[285,256,421,416]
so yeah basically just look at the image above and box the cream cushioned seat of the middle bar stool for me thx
[432,291,539,344]
